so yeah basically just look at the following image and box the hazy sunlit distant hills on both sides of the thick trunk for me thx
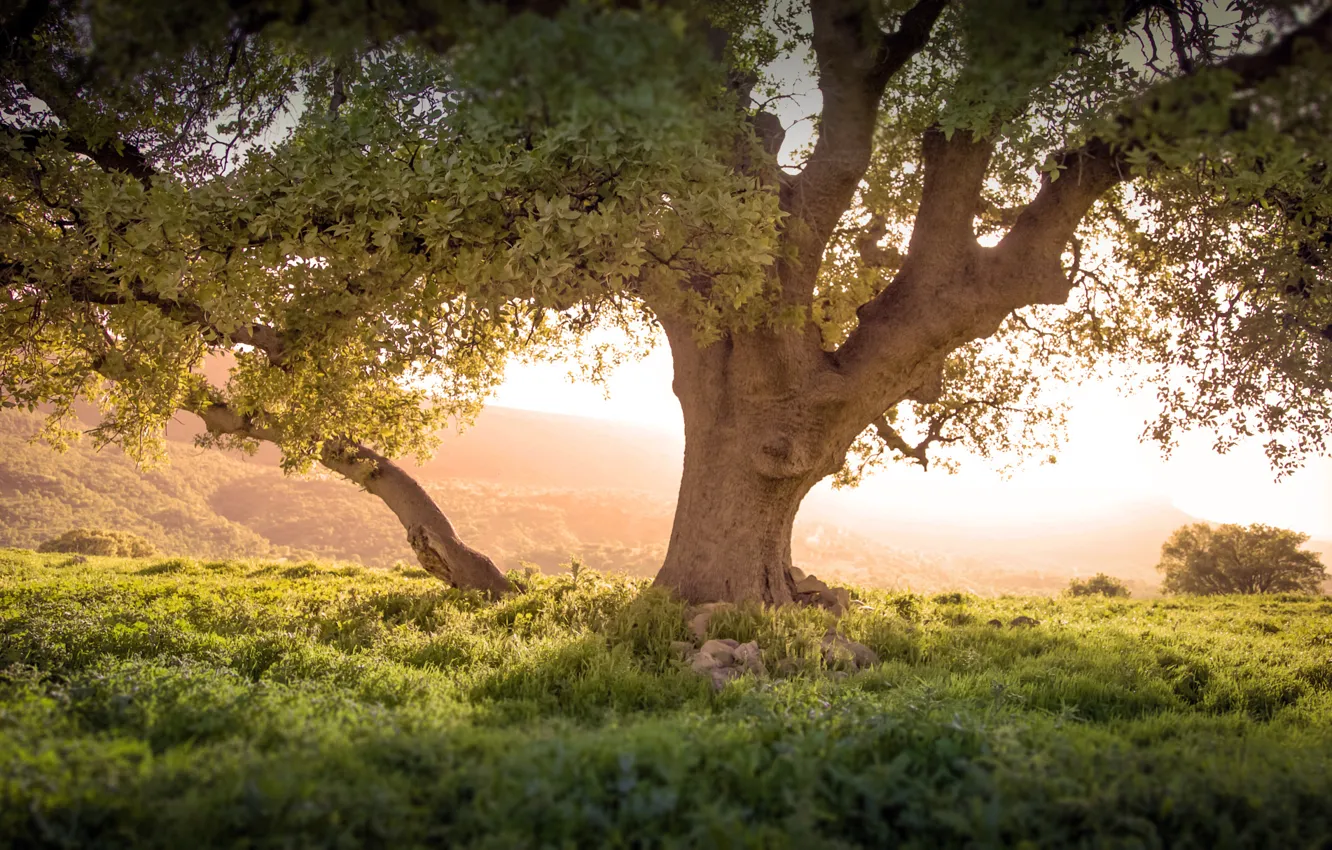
[0,408,1332,594]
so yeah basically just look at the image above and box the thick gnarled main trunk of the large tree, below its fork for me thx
[657,322,855,605]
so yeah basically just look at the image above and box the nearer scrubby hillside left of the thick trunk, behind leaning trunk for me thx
[0,413,670,573]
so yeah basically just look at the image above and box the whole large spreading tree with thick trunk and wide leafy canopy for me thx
[0,0,1332,602]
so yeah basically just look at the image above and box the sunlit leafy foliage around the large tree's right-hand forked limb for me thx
[814,3,1332,484]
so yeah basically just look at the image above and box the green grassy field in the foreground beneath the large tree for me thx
[0,549,1332,850]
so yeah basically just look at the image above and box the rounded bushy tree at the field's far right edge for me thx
[1156,522,1327,594]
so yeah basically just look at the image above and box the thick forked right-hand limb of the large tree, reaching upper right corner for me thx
[834,3,1332,422]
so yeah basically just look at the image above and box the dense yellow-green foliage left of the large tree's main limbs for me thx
[0,5,774,469]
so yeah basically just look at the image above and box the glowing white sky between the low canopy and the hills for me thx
[494,335,1332,537]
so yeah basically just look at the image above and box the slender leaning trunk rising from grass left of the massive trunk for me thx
[321,446,509,596]
